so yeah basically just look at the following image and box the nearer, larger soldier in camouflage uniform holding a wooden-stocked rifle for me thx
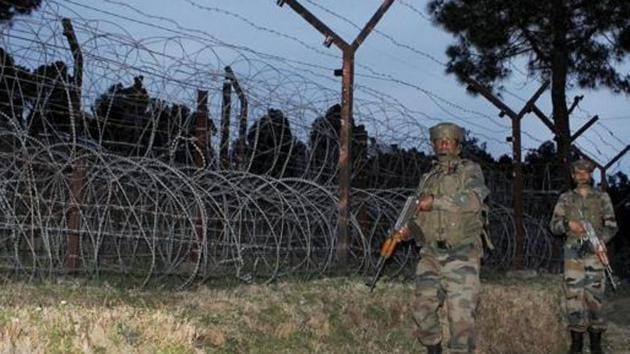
[388,123,489,353]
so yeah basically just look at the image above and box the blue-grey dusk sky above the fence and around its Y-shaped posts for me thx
[34,0,630,174]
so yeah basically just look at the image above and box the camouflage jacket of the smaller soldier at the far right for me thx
[549,187,617,245]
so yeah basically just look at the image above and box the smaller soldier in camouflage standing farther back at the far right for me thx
[550,160,617,353]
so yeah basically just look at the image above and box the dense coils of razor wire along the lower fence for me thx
[0,133,553,286]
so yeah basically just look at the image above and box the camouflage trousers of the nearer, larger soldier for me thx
[413,245,481,353]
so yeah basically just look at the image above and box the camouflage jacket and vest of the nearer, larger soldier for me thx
[410,159,490,248]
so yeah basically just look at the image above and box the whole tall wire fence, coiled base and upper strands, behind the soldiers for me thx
[0,2,559,287]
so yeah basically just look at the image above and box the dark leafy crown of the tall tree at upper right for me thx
[428,0,630,92]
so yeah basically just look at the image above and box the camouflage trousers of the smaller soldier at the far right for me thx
[564,247,606,332]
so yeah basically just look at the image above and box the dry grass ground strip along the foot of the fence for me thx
[0,277,630,353]
